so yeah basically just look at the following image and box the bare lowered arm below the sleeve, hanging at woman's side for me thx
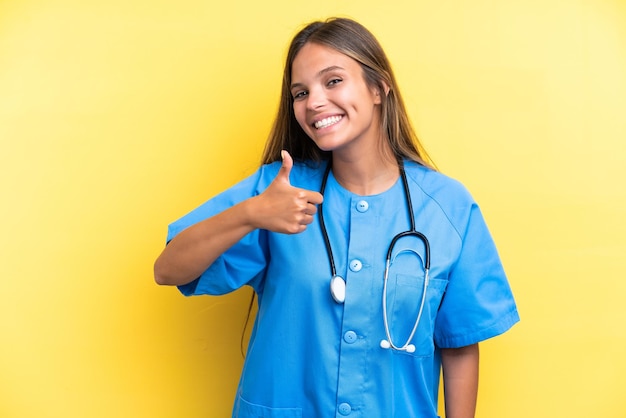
[441,344,479,418]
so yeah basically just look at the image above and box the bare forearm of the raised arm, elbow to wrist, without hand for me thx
[154,200,255,285]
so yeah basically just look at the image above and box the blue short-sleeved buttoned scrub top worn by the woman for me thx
[168,161,519,418]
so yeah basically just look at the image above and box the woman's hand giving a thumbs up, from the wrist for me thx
[249,151,324,234]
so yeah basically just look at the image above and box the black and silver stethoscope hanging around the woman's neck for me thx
[318,161,430,353]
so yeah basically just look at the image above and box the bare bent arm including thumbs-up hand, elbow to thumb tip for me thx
[154,152,323,286]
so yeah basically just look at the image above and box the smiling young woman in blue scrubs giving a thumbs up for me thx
[155,19,519,418]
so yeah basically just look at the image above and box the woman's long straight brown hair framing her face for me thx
[261,18,433,168]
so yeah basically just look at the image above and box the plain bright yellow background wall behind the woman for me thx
[0,0,626,418]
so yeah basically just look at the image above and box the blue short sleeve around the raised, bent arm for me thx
[167,170,267,296]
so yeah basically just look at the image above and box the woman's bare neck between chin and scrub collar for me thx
[333,153,400,196]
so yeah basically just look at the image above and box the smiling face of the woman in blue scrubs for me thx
[291,43,382,157]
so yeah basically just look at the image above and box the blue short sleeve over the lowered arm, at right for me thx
[435,203,519,348]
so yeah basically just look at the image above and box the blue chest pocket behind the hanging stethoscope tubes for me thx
[387,271,448,357]
